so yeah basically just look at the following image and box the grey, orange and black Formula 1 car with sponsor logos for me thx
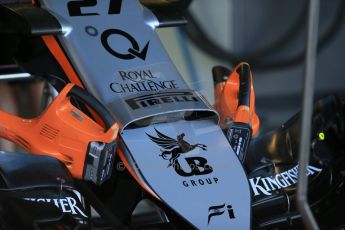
[0,0,345,229]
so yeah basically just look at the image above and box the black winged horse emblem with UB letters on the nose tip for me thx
[146,129,213,177]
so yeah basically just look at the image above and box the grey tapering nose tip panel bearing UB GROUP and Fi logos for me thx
[122,120,251,229]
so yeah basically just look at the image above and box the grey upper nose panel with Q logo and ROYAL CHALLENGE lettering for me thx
[42,0,215,127]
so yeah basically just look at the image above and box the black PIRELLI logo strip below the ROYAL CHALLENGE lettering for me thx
[126,92,199,110]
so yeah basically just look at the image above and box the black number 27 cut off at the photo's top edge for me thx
[67,0,122,16]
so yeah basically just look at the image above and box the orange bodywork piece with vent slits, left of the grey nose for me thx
[0,84,118,179]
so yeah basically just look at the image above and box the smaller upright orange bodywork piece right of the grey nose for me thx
[214,62,260,136]
